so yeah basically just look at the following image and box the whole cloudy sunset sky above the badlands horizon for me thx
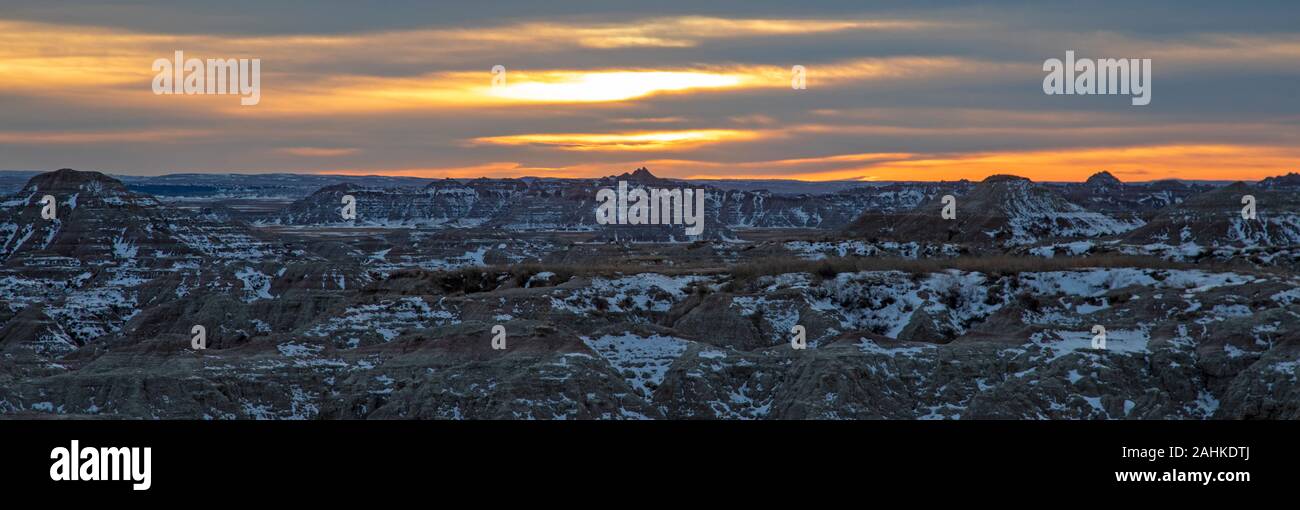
[0,0,1300,181]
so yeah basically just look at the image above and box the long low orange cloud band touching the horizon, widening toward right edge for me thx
[312,144,1300,181]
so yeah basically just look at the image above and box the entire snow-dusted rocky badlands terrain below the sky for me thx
[0,169,1300,419]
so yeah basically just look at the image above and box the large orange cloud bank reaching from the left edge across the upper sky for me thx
[0,12,996,117]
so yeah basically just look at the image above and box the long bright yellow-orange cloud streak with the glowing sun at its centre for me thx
[220,57,982,116]
